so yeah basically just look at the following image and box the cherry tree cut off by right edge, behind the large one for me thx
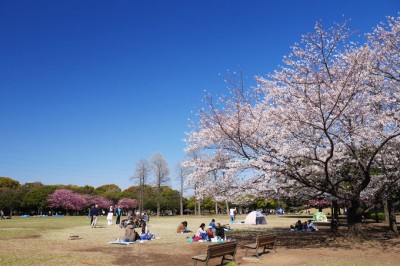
[368,17,400,233]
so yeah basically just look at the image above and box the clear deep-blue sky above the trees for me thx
[0,0,400,189]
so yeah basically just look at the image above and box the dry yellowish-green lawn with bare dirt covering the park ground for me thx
[0,215,400,266]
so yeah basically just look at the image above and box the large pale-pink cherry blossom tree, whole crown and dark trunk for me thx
[187,19,400,241]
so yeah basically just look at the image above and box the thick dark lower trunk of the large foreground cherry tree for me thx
[347,200,363,241]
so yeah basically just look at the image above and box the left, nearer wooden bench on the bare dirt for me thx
[192,241,237,265]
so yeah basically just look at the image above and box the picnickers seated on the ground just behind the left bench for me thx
[176,219,230,242]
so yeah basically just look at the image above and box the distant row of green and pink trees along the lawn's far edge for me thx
[0,177,292,216]
